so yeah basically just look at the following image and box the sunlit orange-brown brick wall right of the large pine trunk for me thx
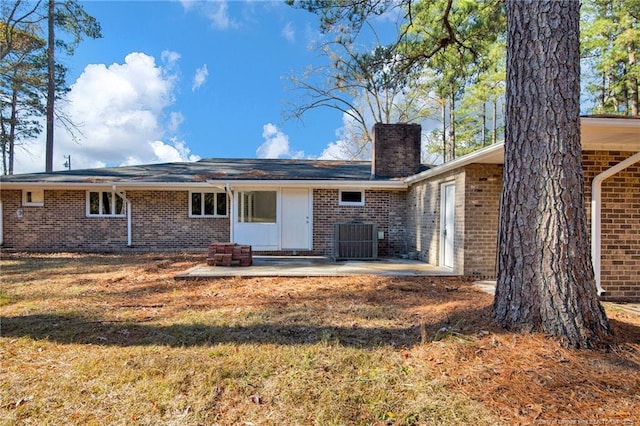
[583,151,640,301]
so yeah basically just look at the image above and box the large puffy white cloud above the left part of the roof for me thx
[11,52,197,173]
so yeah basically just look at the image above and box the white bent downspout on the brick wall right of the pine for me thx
[591,152,640,296]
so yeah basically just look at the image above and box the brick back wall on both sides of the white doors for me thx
[2,189,405,256]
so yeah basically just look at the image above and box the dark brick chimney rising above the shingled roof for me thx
[371,123,422,178]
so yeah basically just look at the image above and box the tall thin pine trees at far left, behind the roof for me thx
[0,0,101,174]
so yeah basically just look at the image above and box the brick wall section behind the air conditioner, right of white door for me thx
[313,189,406,256]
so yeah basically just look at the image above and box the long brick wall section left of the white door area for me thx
[2,190,229,252]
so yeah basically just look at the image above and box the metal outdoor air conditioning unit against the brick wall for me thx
[333,222,378,259]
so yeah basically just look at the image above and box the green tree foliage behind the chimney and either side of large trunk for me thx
[289,0,640,161]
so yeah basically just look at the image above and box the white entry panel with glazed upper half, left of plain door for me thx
[232,190,280,250]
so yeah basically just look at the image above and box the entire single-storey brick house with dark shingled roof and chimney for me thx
[0,117,640,300]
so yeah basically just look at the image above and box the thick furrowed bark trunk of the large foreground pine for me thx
[493,0,611,348]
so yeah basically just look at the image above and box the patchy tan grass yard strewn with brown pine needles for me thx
[0,254,640,425]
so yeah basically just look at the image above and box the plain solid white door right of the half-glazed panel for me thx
[281,188,312,250]
